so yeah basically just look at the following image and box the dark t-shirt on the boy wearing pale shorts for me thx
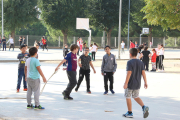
[126,59,144,90]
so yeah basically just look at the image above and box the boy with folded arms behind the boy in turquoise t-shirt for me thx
[17,45,29,93]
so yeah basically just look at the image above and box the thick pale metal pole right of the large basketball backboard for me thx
[118,0,122,59]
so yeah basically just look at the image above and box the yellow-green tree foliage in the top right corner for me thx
[142,0,180,30]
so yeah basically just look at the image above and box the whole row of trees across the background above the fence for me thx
[0,0,180,45]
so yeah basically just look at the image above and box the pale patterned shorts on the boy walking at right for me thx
[124,88,139,98]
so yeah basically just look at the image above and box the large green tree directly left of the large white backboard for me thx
[39,0,87,44]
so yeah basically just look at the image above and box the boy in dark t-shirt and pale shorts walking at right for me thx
[123,48,149,118]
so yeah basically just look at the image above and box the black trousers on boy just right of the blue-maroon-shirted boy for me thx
[76,68,90,91]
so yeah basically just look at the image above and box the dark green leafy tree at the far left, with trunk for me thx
[4,0,39,40]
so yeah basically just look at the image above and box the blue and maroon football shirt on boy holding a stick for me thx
[64,52,77,71]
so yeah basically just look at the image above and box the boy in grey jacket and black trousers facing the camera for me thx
[101,45,117,95]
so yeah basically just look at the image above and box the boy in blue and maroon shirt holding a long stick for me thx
[55,44,79,100]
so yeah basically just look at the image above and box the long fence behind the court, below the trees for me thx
[6,35,180,48]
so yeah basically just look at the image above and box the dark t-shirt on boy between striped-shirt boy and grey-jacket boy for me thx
[79,55,91,70]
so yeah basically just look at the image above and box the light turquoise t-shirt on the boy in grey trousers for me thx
[25,57,41,80]
